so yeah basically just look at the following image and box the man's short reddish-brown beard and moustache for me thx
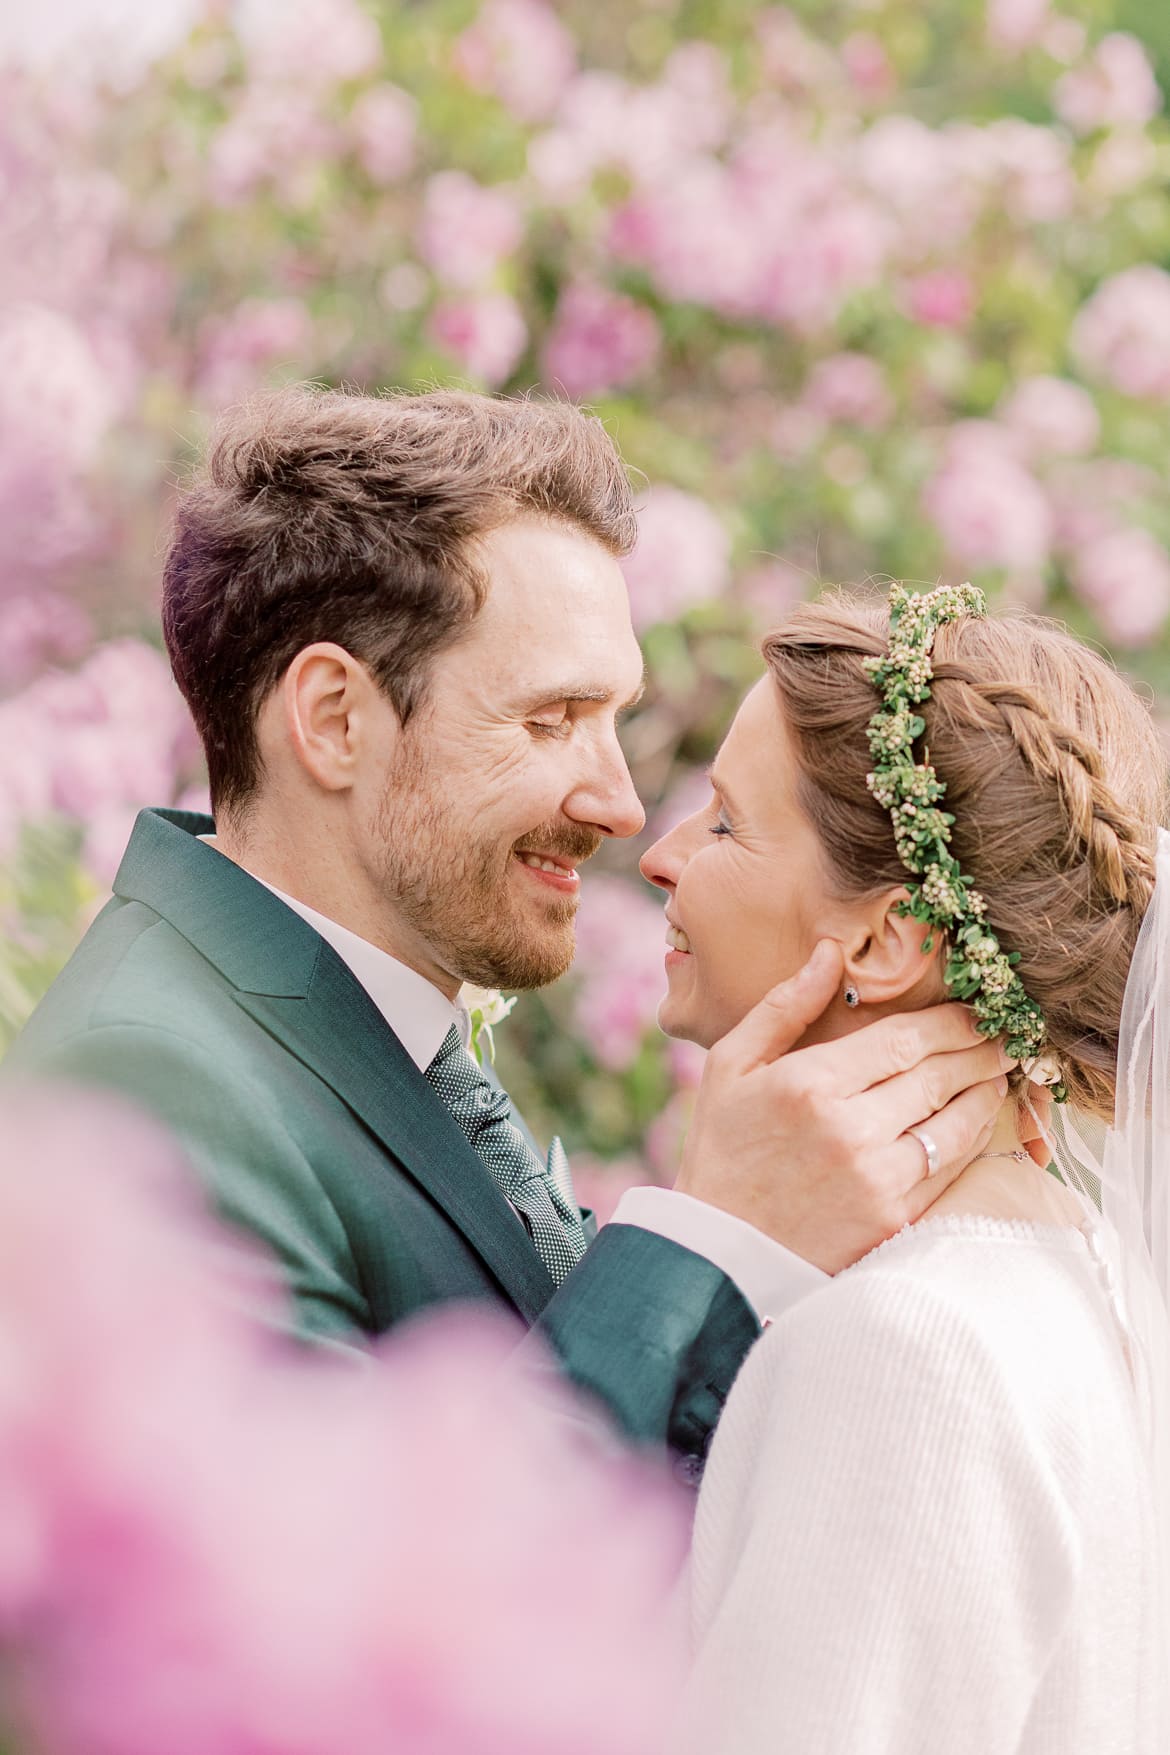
[374,760,603,992]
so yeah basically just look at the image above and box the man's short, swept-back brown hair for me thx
[163,386,635,813]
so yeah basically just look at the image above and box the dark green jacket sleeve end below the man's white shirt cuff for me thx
[535,1225,760,1478]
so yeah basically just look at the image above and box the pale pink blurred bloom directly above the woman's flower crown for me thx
[923,421,1052,572]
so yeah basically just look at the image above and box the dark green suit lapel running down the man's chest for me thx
[114,811,553,1322]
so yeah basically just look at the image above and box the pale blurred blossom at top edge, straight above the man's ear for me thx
[244,0,382,86]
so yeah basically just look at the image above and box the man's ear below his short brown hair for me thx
[265,641,393,792]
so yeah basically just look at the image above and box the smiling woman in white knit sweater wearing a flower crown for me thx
[642,588,1166,1755]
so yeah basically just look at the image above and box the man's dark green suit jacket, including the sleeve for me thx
[5,811,758,1458]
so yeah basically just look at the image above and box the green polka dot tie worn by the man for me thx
[426,1025,586,1285]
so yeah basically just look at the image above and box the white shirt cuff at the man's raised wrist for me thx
[612,1186,830,1323]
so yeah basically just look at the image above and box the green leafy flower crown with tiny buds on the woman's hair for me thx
[865,584,1068,1102]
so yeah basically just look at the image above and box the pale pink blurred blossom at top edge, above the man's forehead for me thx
[454,0,577,121]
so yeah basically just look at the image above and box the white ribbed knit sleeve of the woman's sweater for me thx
[687,1272,1079,1755]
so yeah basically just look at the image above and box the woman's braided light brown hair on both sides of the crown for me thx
[763,593,1166,1118]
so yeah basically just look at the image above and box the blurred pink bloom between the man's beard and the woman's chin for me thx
[574,876,667,1071]
